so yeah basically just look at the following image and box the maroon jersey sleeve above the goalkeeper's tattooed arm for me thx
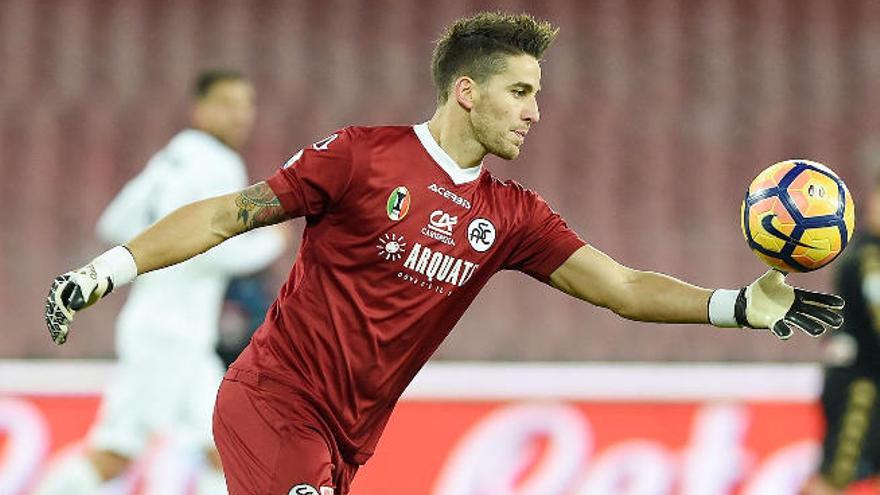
[267,128,354,217]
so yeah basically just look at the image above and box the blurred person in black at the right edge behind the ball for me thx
[801,175,880,495]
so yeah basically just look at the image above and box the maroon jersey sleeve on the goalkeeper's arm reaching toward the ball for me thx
[505,191,586,283]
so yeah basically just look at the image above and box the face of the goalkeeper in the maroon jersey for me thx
[470,55,541,160]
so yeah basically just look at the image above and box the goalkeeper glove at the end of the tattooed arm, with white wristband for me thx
[46,246,137,345]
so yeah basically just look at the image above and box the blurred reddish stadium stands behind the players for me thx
[0,0,880,495]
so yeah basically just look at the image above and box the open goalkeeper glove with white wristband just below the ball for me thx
[709,270,844,340]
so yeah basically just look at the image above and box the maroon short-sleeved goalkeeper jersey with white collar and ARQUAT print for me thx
[233,124,584,464]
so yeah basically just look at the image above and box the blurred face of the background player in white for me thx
[195,80,256,149]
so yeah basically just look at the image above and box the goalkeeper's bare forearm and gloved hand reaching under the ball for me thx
[550,246,843,339]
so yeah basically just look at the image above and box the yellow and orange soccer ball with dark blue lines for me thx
[741,160,855,272]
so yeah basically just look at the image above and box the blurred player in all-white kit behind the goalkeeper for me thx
[36,69,285,495]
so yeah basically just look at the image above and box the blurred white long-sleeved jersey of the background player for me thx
[97,129,284,356]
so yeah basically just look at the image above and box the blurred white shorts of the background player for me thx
[89,351,225,458]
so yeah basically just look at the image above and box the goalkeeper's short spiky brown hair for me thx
[431,12,559,103]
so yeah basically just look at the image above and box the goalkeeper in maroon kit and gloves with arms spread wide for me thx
[47,14,843,495]
